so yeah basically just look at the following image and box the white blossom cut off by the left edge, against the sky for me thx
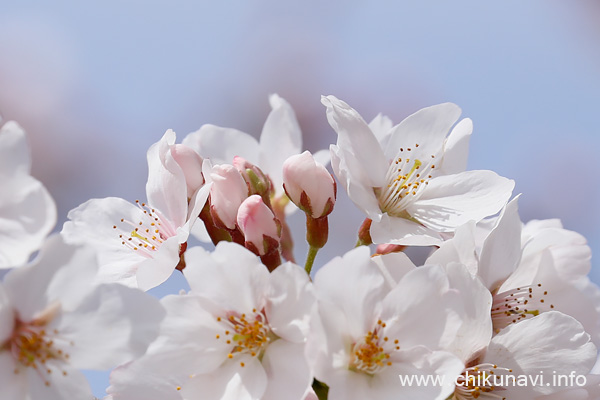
[0,121,56,268]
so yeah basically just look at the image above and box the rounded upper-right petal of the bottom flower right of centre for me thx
[380,266,464,350]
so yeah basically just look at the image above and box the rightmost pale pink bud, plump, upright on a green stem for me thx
[283,151,336,218]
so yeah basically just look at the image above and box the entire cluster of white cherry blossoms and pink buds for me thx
[0,95,600,400]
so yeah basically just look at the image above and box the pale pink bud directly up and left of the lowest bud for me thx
[210,164,248,230]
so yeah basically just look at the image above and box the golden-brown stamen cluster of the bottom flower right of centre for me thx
[349,320,400,375]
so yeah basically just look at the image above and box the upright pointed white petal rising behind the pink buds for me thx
[258,94,302,196]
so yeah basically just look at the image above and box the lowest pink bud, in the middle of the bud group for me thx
[237,194,281,256]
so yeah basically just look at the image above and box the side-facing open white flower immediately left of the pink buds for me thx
[61,130,210,290]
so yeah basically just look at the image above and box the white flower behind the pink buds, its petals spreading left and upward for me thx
[182,94,329,213]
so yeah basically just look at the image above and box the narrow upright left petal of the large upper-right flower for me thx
[321,96,391,187]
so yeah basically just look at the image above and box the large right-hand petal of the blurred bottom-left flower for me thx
[56,284,165,369]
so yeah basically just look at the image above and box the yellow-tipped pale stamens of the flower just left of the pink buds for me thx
[113,200,177,258]
